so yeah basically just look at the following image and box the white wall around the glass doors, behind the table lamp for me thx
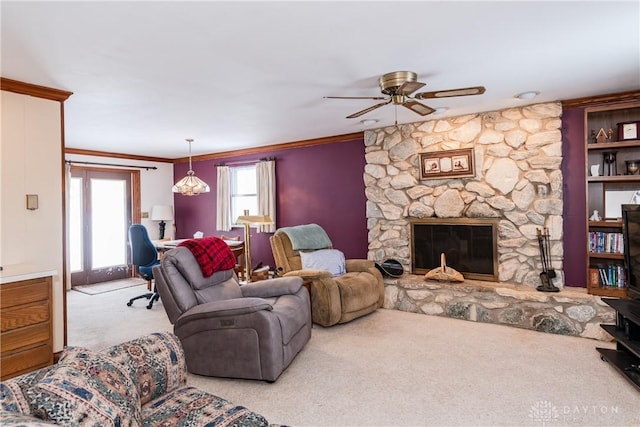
[65,154,175,240]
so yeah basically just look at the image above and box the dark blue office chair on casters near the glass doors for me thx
[127,224,160,309]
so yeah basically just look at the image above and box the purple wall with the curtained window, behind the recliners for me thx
[174,138,368,267]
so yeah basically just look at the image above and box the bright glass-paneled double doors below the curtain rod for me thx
[69,167,132,286]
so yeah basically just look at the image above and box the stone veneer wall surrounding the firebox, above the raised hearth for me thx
[364,103,564,287]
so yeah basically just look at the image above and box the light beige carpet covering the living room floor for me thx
[68,289,640,427]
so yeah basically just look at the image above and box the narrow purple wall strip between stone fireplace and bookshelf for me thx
[562,108,587,287]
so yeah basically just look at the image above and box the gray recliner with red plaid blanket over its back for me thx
[153,247,311,382]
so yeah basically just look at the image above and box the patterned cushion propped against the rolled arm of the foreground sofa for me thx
[28,348,142,427]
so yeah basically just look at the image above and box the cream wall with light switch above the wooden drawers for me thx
[0,91,64,351]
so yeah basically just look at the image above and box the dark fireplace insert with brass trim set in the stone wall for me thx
[411,218,498,282]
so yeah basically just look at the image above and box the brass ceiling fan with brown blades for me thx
[325,71,485,119]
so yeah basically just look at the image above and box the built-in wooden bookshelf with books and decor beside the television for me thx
[584,99,640,298]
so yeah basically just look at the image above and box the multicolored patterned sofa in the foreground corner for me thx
[0,332,269,427]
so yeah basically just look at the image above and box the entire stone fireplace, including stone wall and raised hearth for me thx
[364,103,615,340]
